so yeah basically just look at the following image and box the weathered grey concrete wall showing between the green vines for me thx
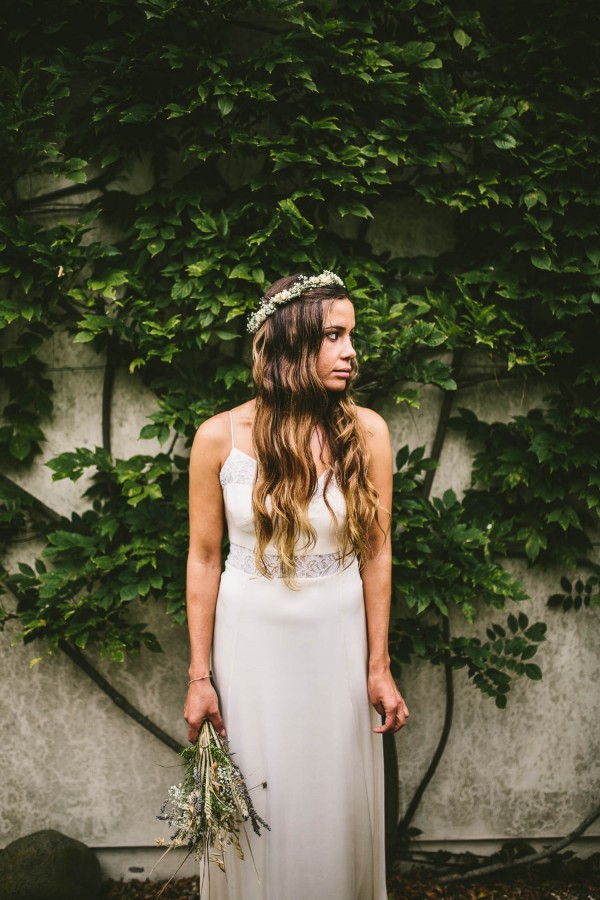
[0,197,600,877]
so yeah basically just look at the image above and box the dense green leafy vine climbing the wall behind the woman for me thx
[0,0,600,856]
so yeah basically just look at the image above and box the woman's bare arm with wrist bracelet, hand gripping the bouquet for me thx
[183,417,225,741]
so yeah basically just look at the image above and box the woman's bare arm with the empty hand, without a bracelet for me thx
[360,408,409,733]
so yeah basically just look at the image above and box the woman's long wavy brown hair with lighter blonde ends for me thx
[252,275,383,588]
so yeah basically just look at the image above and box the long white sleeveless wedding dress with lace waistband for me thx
[201,412,387,900]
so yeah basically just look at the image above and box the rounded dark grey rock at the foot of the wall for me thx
[0,830,102,900]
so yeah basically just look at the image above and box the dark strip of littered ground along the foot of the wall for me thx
[102,872,600,900]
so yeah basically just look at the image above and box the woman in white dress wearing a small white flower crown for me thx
[184,272,408,900]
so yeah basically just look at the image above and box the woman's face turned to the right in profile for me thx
[317,299,356,391]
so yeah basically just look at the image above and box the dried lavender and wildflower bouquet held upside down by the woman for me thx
[157,719,271,884]
